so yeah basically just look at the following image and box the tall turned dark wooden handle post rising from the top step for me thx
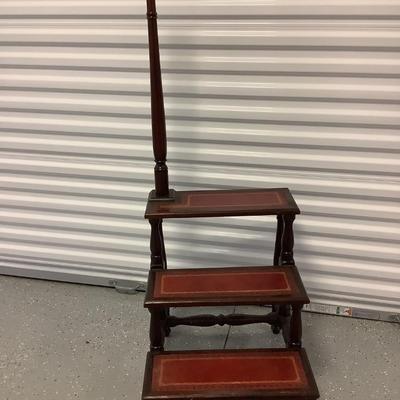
[147,0,173,199]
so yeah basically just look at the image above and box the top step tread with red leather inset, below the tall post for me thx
[145,188,300,219]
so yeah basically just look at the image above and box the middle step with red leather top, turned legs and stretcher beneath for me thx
[145,265,310,350]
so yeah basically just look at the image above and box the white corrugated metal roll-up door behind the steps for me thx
[0,0,400,311]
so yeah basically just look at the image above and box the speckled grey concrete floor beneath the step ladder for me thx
[0,276,400,400]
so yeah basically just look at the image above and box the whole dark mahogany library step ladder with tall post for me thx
[142,0,319,400]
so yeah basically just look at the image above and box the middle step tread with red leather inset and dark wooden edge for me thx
[145,265,310,308]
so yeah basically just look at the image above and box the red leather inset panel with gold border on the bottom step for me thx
[152,351,308,392]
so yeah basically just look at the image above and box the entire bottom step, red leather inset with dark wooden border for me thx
[142,349,319,400]
